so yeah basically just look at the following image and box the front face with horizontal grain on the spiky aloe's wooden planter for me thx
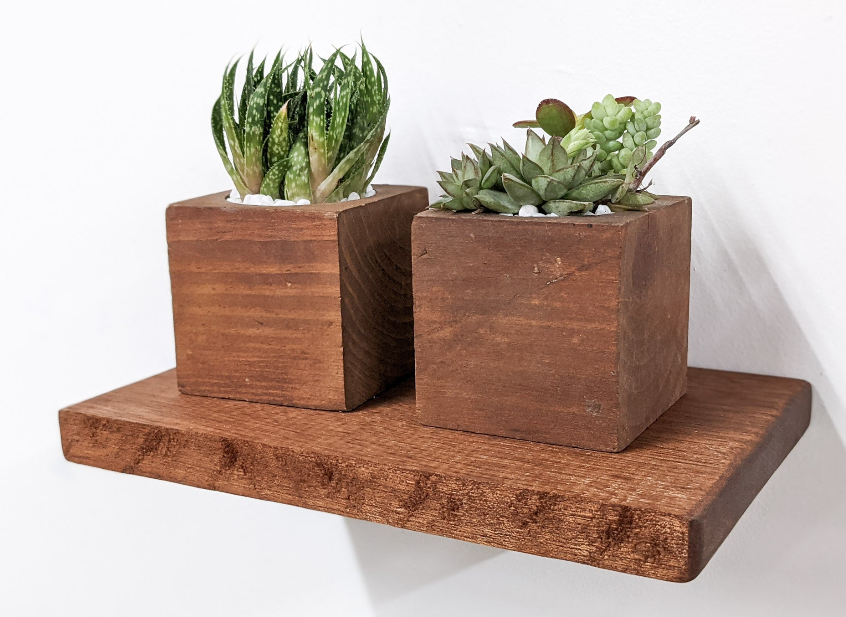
[167,196,346,409]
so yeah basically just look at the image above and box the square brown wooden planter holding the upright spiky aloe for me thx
[167,186,428,411]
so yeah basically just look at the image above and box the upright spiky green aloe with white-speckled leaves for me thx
[217,43,390,203]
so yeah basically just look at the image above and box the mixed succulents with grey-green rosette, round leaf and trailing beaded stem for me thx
[432,95,699,216]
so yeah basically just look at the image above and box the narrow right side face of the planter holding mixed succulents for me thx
[619,197,692,449]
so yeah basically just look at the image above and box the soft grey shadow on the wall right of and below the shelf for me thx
[347,176,846,617]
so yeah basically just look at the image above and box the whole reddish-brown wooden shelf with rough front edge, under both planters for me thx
[59,368,811,582]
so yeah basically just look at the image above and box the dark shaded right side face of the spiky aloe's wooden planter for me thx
[338,187,428,409]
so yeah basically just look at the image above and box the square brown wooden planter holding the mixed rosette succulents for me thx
[412,197,691,452]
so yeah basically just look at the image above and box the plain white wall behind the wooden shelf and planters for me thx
[0,0,846,616]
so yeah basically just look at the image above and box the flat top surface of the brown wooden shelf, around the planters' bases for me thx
[63,368,809,519]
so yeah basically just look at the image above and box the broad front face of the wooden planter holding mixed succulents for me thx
[412,211,623,450]
